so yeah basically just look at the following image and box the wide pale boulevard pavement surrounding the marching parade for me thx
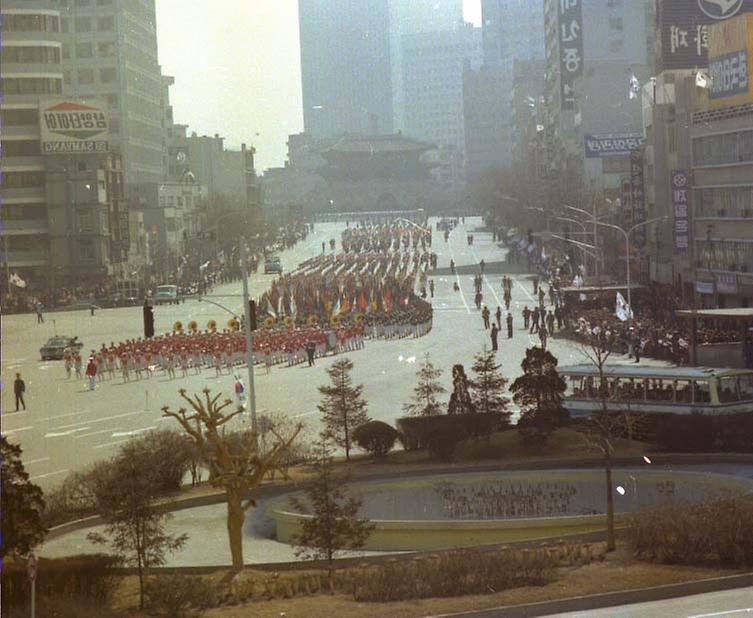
[2,219,664,487]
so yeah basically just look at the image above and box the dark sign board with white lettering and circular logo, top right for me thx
[656,0,753,73]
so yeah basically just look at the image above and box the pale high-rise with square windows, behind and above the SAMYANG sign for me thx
[60,0,164,185]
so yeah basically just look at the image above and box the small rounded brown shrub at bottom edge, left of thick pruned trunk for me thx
[145,575,217,618]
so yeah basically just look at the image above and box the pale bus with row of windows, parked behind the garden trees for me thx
[559,364,753,418]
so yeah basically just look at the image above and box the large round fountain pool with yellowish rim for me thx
[266,468,753,551]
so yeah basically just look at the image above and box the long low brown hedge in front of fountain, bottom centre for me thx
[353,550,556,602]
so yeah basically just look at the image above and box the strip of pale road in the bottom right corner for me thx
[553,588,753,618]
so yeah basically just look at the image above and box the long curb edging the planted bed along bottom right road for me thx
[431,573,753,618]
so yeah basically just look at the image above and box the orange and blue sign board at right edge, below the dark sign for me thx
[709,13,753,107]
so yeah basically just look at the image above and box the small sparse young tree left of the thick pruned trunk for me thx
[87,448,188,609]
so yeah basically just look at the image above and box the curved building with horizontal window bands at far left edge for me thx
[0,0,63,282]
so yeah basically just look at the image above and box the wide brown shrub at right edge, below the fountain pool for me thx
[629,495,753,568]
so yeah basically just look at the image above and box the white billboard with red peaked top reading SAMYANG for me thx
[39,101,109,154]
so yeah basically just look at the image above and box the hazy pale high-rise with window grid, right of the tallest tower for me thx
[401,24,481,151]
